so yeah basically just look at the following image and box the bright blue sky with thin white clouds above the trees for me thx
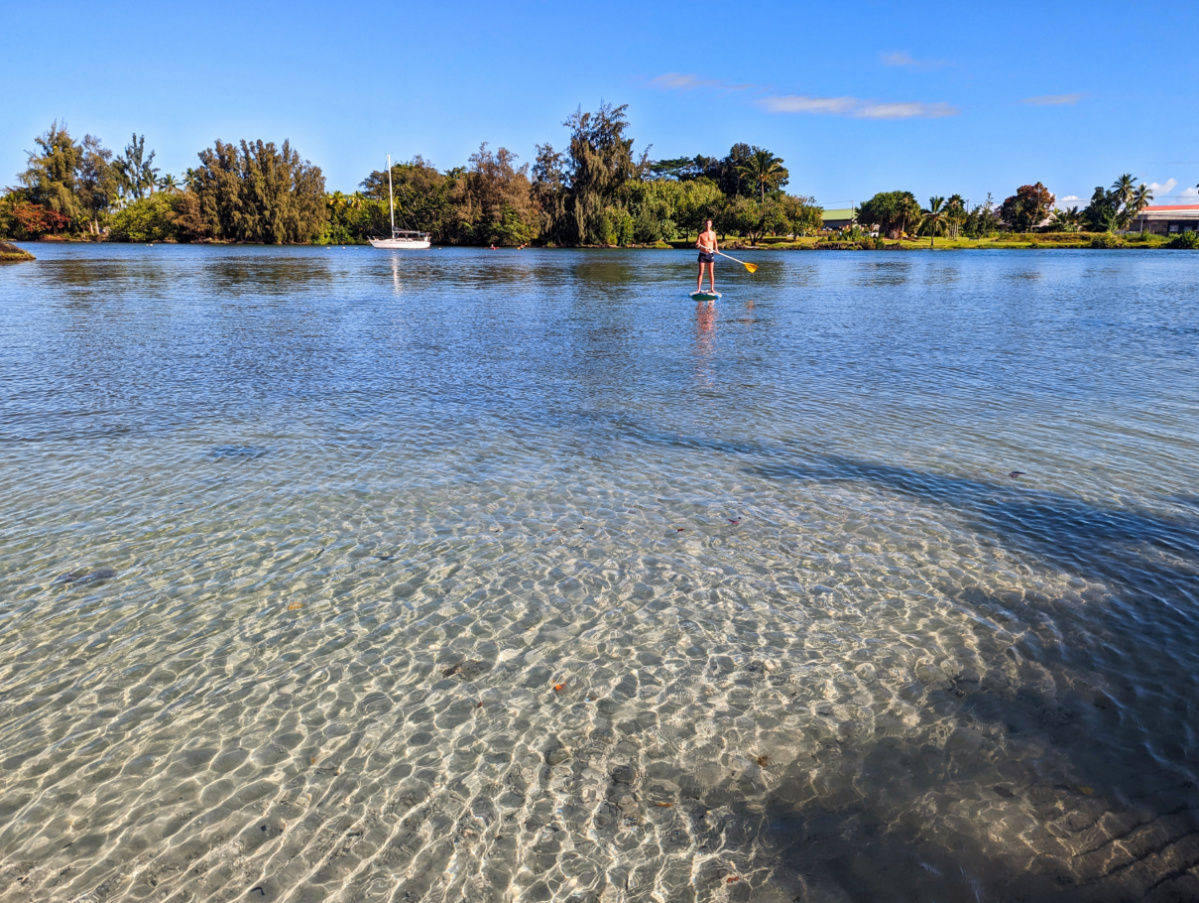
[0,0,1199,207]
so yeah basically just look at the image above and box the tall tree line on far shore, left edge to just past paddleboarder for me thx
[0,110,823,246]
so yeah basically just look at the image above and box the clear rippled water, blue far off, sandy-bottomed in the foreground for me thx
[0,246,1199,903]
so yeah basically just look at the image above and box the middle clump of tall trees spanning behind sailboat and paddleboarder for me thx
[338,106,821,246]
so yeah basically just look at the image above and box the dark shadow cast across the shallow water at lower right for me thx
[625,423,1199,902]
